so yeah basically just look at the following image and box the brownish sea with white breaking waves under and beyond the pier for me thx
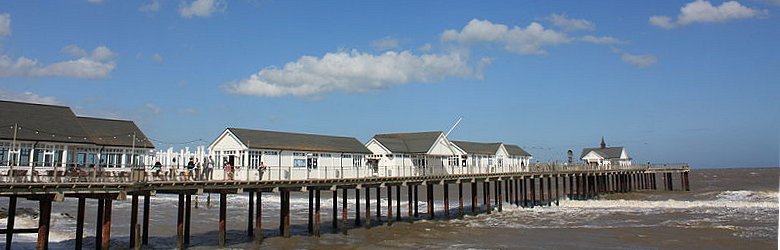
[0,167,780,249]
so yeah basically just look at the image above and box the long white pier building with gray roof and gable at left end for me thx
[208,128,371,180]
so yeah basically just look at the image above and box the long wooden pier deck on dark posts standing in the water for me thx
[0,165,690,249]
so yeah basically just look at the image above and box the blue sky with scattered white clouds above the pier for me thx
[0,0,780,167]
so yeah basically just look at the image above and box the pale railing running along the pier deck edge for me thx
[0,163,689,183]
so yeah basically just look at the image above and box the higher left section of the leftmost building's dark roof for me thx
[0,101,92,144]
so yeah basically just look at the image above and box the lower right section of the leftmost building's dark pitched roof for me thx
[77,117,154,148]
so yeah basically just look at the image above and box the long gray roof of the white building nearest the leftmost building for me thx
[228,128,371,154]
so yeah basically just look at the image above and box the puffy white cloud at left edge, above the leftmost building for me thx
[0,45,117,79]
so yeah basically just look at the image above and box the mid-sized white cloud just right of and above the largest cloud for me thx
[441,19,571,55]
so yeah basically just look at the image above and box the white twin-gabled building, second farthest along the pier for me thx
[452,141,531,172]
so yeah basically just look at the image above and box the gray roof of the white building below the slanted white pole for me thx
[374,131,443,154]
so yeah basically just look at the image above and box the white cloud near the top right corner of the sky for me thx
[649,0,769,29]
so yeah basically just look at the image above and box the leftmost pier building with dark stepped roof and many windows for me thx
[0,101,154,171]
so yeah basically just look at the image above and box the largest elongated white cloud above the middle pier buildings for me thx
[225,50,472,96]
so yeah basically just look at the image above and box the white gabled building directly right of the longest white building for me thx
[366,131,463,176]
